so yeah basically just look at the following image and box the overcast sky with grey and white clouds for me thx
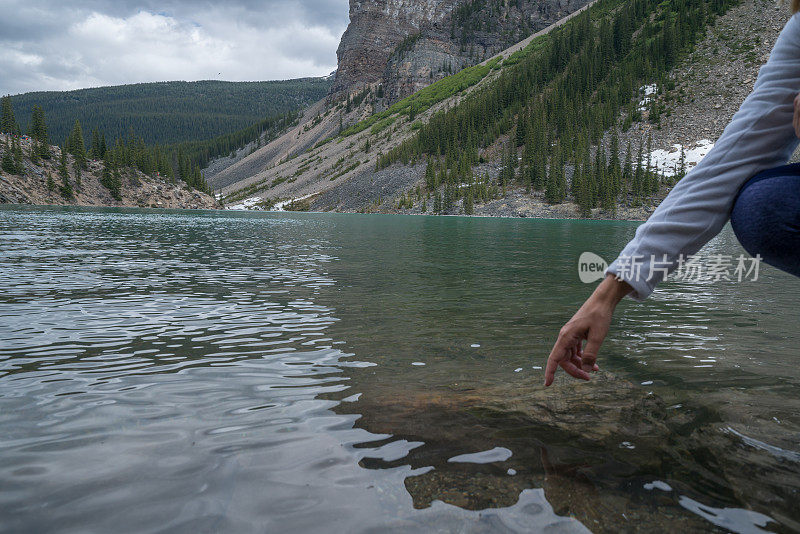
[0,0,348,94]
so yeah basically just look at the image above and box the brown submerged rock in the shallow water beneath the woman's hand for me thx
[337,373,800,532]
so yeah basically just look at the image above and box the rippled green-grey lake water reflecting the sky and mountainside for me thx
[0,208,800,532]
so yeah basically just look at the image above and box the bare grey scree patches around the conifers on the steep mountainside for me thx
[212,0,789,220]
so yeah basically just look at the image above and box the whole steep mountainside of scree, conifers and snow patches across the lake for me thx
[210,0,789,219]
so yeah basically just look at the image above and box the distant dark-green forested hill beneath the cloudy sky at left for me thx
[11,77,332,148]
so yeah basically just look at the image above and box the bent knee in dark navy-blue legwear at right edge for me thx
[731,163,800,276]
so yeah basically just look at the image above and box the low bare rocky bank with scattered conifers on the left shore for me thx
[0,135,220,209]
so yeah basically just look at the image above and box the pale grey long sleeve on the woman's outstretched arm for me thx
[606,13,800,301]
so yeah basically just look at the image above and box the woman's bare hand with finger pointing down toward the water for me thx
[544,274,633,386]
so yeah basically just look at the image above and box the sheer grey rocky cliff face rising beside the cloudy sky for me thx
[333,0,587,102]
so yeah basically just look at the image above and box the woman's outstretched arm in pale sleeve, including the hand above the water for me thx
[545,14,800,386]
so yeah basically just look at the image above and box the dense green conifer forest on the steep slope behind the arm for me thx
[378,0,737,215]
